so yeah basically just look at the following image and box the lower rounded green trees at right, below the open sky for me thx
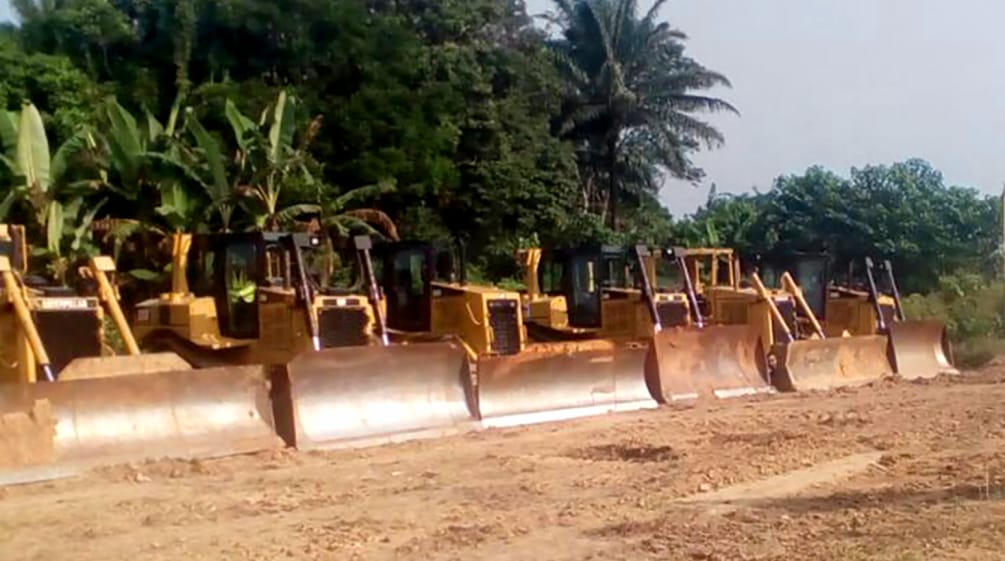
[675,160,1001,293]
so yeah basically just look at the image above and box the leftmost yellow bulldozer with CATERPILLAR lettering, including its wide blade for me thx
[0,224,281,485]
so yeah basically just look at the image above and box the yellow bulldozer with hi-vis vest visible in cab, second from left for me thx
[134,232,476,449]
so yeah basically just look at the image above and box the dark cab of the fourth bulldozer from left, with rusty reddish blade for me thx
[538,245,637,329]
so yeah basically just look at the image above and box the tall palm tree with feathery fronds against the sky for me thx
[551,0,737,228]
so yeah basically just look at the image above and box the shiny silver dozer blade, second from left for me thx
[273,342,477,449]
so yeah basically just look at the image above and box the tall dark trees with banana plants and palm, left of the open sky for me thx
[0,0,729,281]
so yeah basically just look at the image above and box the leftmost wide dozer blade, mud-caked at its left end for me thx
[0,366,282,485]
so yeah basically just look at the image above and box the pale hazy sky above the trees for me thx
[0,0,1005,215]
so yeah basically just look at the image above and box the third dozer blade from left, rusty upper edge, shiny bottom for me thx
[478,341,658,427]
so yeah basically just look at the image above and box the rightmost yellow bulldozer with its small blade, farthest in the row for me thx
[759,253,959,379]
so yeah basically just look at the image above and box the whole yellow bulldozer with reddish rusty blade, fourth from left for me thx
[519,244,772,403]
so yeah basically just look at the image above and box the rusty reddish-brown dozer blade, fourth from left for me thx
[648,326,774,403]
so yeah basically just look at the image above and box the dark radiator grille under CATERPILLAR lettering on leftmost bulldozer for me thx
[32,310,102,373]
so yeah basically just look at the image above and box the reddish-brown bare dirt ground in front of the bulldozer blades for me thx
[0,366,1005,561]
